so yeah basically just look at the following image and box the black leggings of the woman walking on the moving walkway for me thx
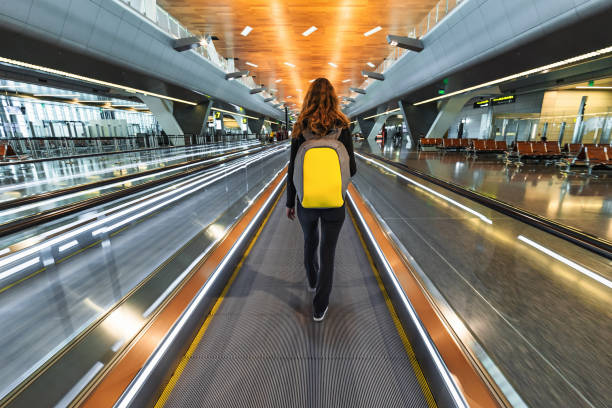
[297,200,346,313]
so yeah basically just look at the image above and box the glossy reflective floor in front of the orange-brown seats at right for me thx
[355,141,612,241]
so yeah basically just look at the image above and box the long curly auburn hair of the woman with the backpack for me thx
[292,78,349,138]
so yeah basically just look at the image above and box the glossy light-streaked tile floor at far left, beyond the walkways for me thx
[0,141,254,202]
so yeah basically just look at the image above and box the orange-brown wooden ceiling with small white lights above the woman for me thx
[158,0,438,107]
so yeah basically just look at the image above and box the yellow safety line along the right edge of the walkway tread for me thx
[349,211,438,408]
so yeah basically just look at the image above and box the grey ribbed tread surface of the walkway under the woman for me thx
[158,197,435,407]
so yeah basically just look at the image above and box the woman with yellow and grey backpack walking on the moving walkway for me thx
[287,78,356,322]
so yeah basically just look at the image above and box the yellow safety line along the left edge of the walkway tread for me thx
[155,187,285,408]
